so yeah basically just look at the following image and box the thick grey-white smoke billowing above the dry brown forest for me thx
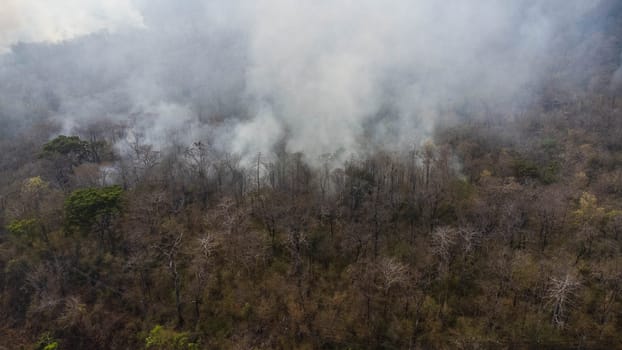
[0,0,616,160]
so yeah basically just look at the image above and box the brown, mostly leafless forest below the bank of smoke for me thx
[0,96,622,349]
